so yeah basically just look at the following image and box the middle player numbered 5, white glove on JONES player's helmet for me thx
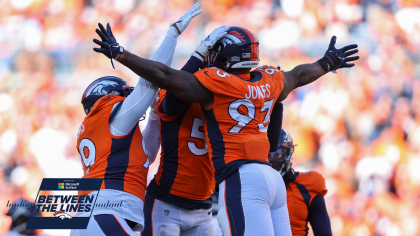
[142,26,229,236]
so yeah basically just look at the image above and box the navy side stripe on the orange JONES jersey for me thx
[203,109,226,171]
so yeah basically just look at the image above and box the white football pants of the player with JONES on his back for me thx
[217,163,292,236]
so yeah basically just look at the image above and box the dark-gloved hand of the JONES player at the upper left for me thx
[93,23,124,69]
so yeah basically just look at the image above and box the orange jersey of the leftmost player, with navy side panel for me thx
[77,95,148,201]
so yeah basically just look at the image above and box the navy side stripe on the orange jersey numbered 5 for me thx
[159,108,188,193]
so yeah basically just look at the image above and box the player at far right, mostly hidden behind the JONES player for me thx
[268,124,332,236]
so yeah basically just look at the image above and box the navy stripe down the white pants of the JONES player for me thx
[225,171,245,236]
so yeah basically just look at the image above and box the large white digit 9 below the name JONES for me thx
[229,99,255,133]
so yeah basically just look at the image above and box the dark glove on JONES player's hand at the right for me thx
[318,36,359,73]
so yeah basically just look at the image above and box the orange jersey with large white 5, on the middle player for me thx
[148,89,215,209]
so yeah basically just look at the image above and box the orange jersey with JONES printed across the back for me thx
[194,66,284,183]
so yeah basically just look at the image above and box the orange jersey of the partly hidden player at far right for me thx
[286,171,327,235]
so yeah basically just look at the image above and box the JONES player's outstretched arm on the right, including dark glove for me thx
[277,36,359,102]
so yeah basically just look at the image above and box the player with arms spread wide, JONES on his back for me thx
[94,23,359,236]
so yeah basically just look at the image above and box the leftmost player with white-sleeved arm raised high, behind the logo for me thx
[71,3,202,236]
